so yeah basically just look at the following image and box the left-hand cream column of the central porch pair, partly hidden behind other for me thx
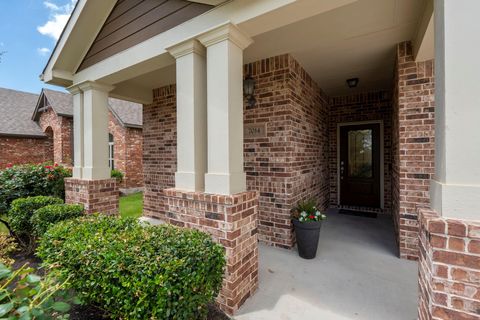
[168,40,207,191]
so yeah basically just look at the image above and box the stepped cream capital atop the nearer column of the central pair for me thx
[197,22,253,50]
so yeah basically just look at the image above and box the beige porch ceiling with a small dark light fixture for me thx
[245,0,426,96]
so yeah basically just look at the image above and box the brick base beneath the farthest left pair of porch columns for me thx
[65,178,119,215]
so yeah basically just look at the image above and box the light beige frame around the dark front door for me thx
[337,120,385,210]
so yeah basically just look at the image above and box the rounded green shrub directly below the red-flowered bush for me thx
[7,196,63,242]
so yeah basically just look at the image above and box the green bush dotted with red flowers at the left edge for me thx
[0,164,71,215]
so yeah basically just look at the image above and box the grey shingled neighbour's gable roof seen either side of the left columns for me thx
[31,89,143,128]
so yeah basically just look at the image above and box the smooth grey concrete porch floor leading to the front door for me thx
[235,209,418,320]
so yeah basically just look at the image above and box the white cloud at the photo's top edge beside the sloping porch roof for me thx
[37,0,77,40]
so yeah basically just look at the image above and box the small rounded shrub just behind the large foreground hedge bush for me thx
[30,204,84,237]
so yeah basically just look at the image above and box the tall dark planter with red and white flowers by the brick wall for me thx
[292,199,327,259]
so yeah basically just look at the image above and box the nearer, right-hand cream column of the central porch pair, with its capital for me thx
[198,23,252,195]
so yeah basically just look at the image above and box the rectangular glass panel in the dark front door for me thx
[348,129,373,178]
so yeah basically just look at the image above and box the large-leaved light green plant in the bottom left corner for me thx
[0,264,80,320]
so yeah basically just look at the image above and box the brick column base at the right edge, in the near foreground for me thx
[418,208,480,320]
